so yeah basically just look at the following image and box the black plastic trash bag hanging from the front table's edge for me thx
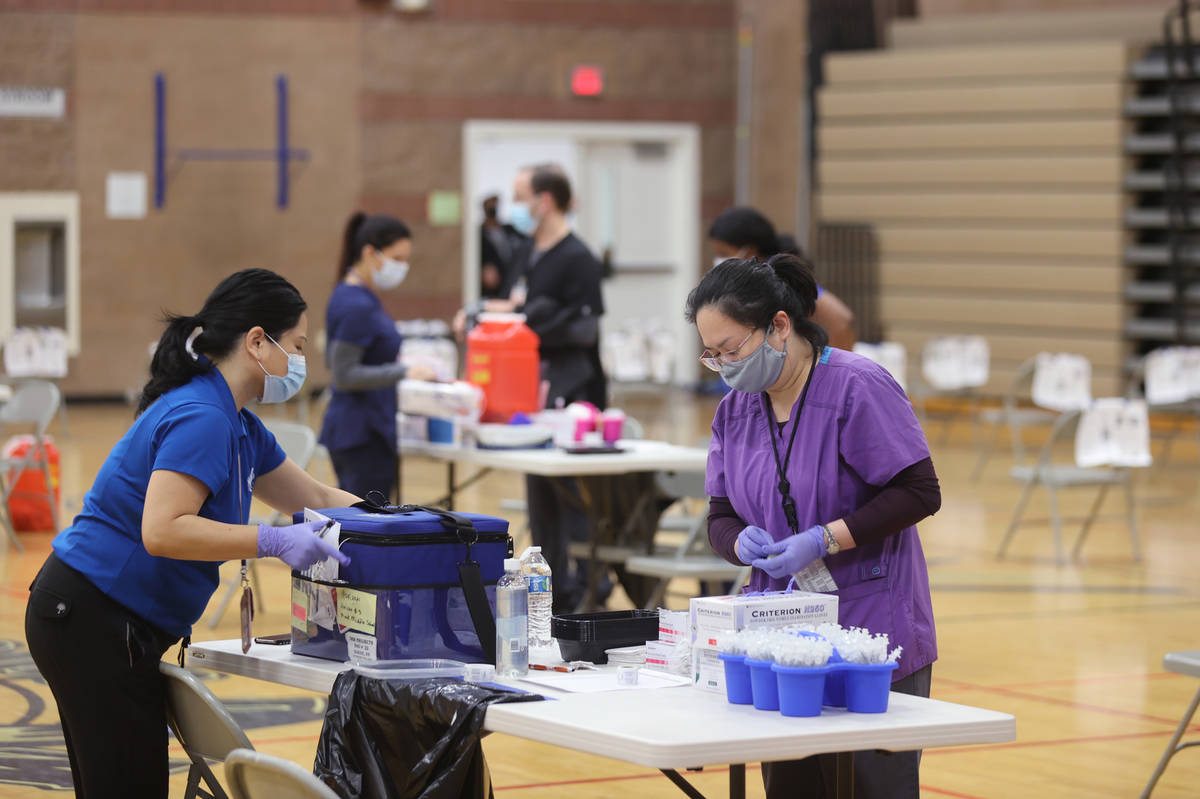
[313,669,542,799]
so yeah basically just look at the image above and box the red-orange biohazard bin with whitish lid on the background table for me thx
[467,313,540,422]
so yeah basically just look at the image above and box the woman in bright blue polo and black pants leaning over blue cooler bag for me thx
[25,269,358,797]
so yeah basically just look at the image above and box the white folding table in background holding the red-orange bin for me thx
[401,439,708,609]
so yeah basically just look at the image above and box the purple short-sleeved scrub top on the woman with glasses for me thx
[704,347,937,680]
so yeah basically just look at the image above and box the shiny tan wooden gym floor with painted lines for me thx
[0,394,1200,799]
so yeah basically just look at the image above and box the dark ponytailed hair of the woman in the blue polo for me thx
[137,269,308,416]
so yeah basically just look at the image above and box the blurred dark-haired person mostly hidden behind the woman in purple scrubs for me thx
[708,206,854,349]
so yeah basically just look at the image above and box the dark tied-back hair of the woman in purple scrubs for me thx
[684,253,829,352]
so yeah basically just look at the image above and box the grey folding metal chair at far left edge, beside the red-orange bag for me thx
[0,380,62,544]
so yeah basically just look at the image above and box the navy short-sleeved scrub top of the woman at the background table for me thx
[319,283,403,452]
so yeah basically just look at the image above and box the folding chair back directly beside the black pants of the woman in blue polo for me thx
[158,662,254,799]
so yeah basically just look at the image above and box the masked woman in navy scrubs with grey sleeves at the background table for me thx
[320,212,436,497]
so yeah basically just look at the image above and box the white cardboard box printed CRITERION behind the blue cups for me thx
[690,591,838,693]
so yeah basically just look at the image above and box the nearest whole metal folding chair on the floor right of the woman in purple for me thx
[996,410,1141,564]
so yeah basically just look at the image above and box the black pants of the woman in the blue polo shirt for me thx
[25,554,176,799]
